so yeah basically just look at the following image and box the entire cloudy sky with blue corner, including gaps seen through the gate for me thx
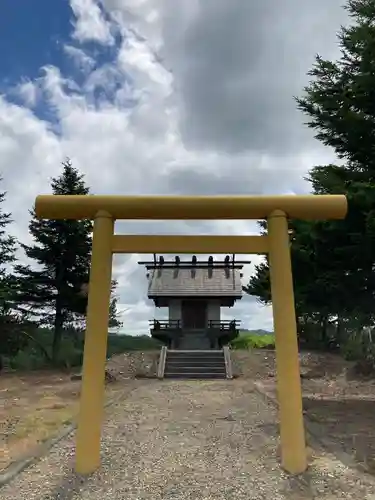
[0,0,347,333]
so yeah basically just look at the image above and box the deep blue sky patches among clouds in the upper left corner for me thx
[0,0,125,118]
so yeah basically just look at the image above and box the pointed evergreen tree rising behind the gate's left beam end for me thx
[16,160,92,362]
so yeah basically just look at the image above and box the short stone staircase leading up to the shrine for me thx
[164,349,227,379]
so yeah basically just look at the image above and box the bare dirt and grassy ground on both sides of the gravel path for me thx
[0,351,375,492]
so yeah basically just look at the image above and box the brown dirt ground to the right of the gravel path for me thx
[234,351,375,475]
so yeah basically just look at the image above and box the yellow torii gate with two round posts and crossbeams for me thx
[35,195,347,474]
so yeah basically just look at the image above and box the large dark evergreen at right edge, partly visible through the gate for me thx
[245,0,375,344]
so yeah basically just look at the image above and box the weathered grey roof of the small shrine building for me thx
[148,266,242,299]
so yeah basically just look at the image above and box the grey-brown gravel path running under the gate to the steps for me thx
[0,380,375,500]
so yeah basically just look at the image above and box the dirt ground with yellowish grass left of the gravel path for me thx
[0,352,158,474]
